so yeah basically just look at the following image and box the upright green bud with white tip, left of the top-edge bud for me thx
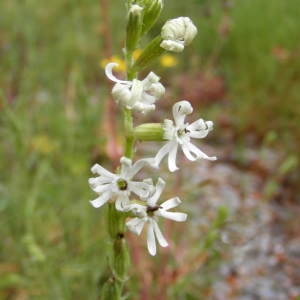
[126,4,143,53]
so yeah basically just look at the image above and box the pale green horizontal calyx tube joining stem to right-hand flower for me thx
[133,123,164,141]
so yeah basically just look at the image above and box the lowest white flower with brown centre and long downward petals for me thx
[126,178,187,255]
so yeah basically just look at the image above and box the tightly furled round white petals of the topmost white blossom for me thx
[160,17,197,52]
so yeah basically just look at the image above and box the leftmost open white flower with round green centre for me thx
[89,157,152,211]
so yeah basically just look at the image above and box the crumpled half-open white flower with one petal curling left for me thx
[105,63,165,113]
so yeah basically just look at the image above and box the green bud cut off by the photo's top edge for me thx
[141,0,163,35]
